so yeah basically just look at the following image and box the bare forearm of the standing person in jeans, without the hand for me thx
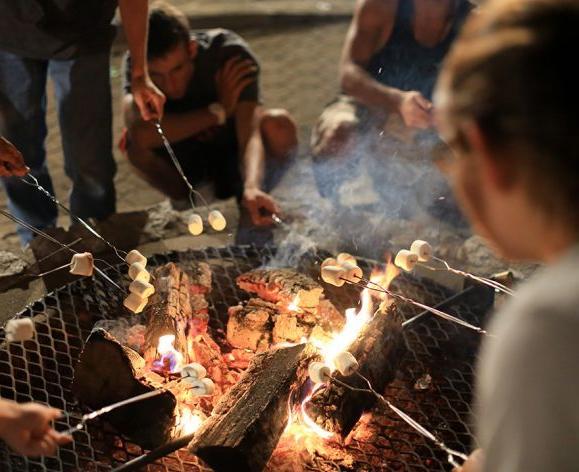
[119,0,149,78]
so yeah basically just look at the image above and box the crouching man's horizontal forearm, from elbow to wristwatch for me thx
[129,108,218,149]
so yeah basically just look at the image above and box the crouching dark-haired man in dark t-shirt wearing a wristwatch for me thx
[124,4,297,226]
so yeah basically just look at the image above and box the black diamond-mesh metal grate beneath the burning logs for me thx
[0,246,492,471]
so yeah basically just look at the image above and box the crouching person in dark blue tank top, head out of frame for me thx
[311,0,473,196]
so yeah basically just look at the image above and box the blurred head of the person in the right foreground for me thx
[435,0,579,257]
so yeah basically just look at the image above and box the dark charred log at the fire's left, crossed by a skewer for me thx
[72,329,177,449]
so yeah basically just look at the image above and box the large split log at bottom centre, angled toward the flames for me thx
[189,344,314,472]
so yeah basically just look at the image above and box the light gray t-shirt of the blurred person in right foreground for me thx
[477,245,579,472]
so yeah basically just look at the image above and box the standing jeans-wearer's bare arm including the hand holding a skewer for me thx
[119,0,165,121]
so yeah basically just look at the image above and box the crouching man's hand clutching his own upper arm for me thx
[215,56,257,118]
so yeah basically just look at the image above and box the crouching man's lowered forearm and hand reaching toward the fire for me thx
[235,102,279,226]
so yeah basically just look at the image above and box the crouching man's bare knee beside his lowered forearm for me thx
[260,109,298,159]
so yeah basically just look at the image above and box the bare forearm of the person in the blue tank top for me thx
[341,63,402,113]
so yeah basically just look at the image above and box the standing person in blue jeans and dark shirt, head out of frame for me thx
[0,0,164,243]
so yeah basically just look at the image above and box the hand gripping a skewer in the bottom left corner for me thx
[0,401,72,457]
